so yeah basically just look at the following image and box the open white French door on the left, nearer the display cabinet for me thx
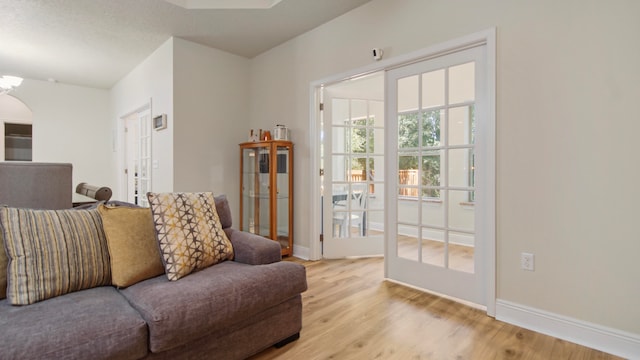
[322,73,385,258]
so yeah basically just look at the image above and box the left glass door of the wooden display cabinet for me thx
[242,147,271,238]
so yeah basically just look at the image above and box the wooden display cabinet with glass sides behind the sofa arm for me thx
[240,140,293,256]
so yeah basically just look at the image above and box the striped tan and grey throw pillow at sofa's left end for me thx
[0,207,111,305]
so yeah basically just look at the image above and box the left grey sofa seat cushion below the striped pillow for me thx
[0,287,148,359]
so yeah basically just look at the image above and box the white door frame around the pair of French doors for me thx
[308,28,496,316]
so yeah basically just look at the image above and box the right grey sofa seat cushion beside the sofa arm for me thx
[120,261,307,352]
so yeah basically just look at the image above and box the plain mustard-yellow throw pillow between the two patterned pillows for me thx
[98,205,164,287]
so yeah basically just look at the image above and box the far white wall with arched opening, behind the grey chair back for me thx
[11,79,116,188]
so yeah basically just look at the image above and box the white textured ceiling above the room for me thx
[0,0,370,89]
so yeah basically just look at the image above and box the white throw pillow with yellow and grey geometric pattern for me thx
[147,192,233,281]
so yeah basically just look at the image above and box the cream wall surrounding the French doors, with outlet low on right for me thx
[250,0,640,340]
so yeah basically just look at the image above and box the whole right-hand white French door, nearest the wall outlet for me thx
[385,46,488,305]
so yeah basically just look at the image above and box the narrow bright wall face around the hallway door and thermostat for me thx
[109,38,174,200]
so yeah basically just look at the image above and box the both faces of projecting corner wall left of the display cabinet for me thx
[111,38,249,214]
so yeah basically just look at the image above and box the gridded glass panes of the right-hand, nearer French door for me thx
[396,62,475,272]
